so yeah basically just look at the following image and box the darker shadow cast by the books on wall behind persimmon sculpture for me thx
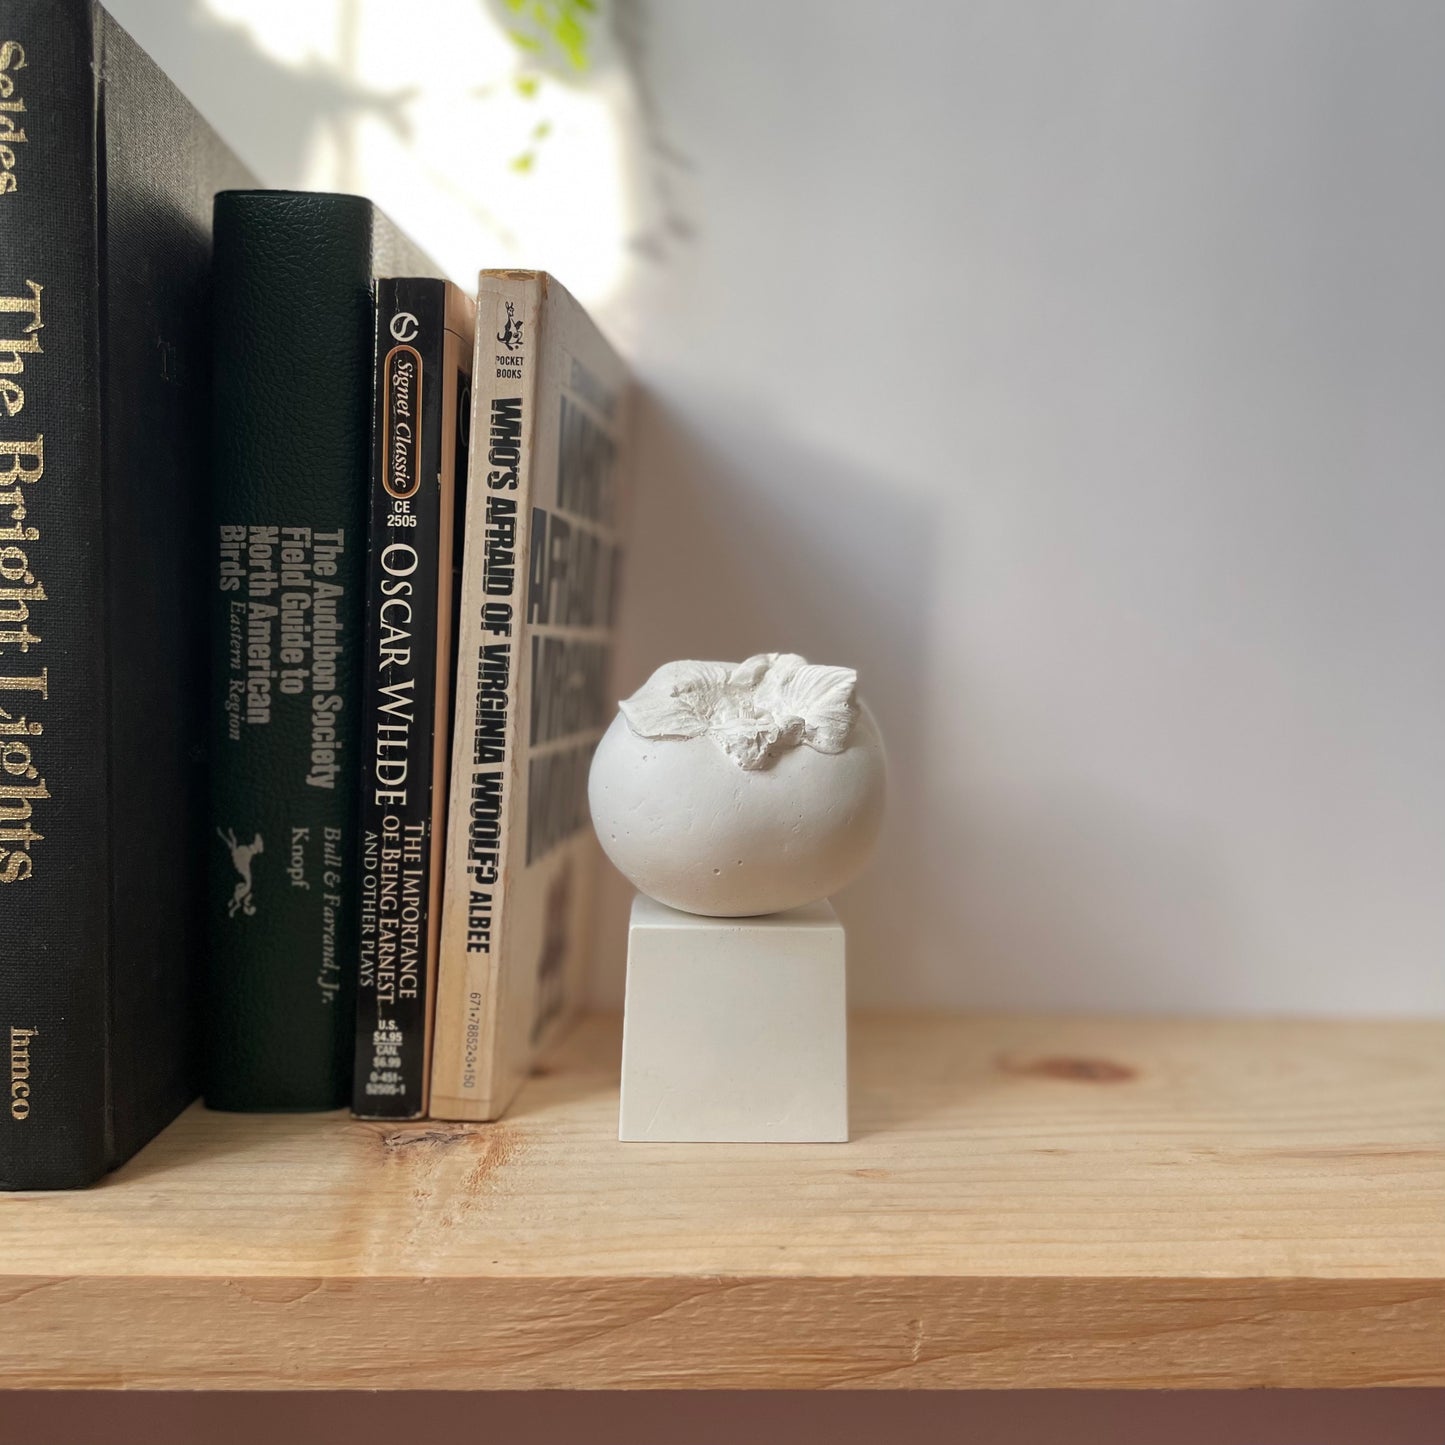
[592,390,936,1006]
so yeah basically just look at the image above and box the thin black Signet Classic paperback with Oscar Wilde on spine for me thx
[351,277,475,1118]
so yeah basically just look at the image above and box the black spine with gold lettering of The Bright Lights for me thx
[0,0,111,1189]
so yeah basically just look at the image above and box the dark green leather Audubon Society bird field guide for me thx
[205,191,435,1110]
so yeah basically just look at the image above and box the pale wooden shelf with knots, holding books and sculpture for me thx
[0,1016,1445,1389]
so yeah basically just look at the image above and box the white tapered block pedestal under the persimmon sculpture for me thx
[617,893,848,1143]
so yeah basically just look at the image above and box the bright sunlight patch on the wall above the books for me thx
[202,0,629,306]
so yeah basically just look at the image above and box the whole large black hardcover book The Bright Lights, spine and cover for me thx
[0,0,250,1189]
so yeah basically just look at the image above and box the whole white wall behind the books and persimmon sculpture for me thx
[110,0,1445,1013]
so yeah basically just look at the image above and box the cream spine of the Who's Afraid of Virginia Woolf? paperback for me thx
[431,272,542,1120]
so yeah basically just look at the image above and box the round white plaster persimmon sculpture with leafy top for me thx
[588,653,884,918]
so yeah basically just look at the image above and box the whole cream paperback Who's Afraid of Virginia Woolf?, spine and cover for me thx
[431,270,630,1120]
